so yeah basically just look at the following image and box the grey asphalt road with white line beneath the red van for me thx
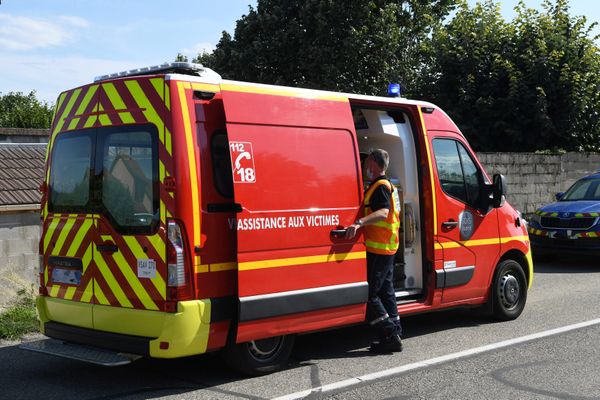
[0,257,600,400]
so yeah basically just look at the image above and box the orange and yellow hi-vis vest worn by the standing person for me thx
[365,179,400,255]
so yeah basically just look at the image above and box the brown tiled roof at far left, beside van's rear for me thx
[0,143,46,206]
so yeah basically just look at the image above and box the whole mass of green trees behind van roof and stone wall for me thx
[185,0,600,151]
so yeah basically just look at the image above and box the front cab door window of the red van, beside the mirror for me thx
[433,139,481,207]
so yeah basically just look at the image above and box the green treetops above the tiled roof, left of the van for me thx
[0,91,53,128]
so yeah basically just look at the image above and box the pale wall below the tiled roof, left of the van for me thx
[0,211,40,309]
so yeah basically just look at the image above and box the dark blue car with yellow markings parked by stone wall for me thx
[529,170,600,255]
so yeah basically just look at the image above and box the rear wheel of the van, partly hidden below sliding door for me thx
[223,335,295,376]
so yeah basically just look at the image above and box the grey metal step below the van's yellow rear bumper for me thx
[19,339,141,367]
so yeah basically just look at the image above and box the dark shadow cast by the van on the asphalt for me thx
[0,309,492,400]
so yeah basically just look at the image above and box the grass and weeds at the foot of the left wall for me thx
[0,289,39,340]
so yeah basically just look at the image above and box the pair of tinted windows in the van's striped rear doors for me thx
[48,125,160,234]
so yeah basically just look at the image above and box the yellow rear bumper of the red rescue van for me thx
[37,296,211,358]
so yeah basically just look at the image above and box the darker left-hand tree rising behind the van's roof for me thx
[194,0,455,94]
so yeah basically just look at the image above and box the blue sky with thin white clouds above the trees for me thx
[0,0,600,103]
